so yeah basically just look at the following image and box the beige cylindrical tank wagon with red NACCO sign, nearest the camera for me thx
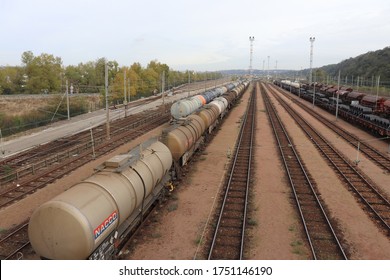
[28,139,172,259]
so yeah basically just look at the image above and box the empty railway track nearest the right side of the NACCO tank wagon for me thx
[208,86,256,260]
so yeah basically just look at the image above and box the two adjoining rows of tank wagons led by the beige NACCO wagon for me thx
[28,81,249,260]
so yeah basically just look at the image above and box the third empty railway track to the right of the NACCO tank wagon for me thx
[268,83,390,236]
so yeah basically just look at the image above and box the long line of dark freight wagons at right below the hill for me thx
[274,80,390,136]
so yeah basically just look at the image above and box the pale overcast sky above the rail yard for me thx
[0,0,390,71]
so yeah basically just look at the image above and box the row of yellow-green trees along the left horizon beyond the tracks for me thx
[0,51,222,101]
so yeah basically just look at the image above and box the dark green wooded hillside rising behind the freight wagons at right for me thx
[318,47,390,86]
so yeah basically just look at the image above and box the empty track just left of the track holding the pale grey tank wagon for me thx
[0,109,170,208]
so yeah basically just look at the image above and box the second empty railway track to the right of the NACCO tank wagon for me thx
[261,82,347,260]
